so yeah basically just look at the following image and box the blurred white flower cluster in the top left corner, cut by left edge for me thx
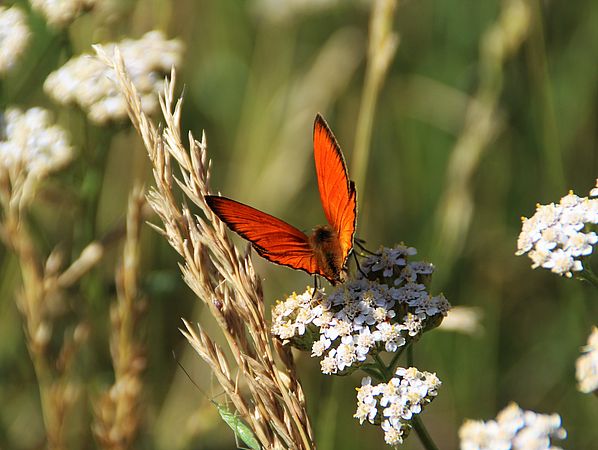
[0,6,31,75]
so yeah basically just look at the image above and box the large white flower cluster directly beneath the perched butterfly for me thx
[272,245,450,374]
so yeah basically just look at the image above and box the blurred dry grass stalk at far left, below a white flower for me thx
[0,168,92,449]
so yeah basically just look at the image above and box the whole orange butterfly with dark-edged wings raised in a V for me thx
[205,114,357,284]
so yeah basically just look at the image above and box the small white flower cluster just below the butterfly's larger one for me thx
[353,367,441,445]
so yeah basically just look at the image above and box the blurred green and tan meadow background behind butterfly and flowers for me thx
[0,0,598,449]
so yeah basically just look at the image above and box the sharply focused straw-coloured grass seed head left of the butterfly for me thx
[96,47,314,449]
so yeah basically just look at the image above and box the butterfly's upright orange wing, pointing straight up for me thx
[314,114,357,264]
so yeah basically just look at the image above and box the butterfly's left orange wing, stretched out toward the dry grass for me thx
[205,195,323,275]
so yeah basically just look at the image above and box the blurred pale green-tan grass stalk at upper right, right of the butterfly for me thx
[433,0,530,273]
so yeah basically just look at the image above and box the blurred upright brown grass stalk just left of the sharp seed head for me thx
[93,187,146,450]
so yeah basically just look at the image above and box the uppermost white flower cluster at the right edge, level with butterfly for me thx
[515,181,598,277]
